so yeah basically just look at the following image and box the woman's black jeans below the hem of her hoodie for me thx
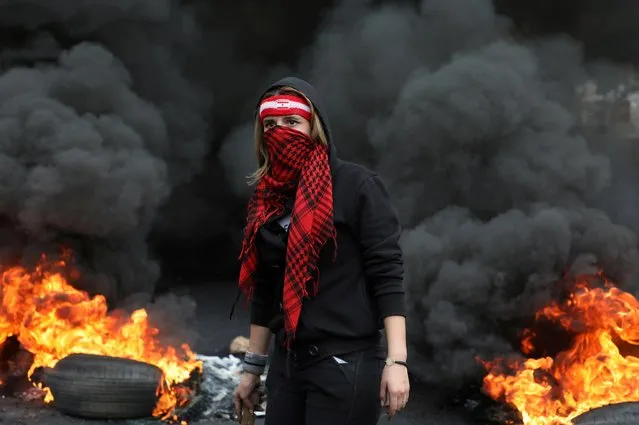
[265,351,383,425]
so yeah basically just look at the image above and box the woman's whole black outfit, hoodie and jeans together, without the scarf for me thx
[245,78,405,425]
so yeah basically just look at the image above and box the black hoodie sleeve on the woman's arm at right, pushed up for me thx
[357,175,406,319]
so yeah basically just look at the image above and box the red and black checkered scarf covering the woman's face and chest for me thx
[239,126,335,346]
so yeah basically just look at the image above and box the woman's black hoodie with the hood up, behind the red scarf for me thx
[251,77,405,354]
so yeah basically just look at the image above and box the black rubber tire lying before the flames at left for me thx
[43,354,163,419]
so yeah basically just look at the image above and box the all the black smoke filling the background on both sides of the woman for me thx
[0,0,639,385]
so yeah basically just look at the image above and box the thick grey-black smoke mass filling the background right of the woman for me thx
[219,0,638,386]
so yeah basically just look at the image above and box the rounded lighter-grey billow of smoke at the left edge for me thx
[0,44,169,237]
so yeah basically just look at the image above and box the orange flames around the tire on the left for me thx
[0,253,202,418]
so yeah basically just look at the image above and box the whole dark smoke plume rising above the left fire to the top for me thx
[0,0,212,314]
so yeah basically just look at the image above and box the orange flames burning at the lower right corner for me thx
[482,274,639,425]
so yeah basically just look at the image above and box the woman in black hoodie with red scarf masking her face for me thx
[234,77,410,425]
